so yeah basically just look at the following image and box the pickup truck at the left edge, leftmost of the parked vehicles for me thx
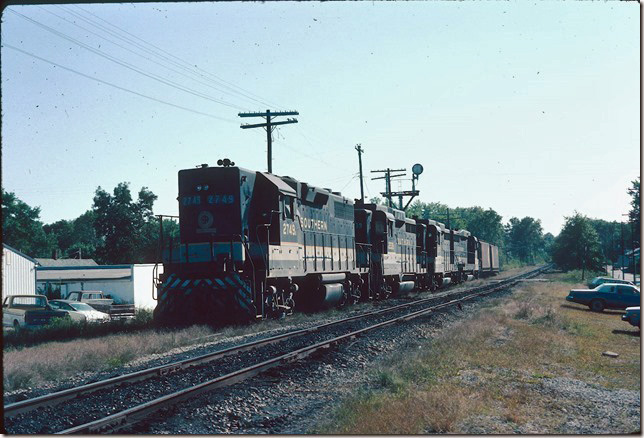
[2,295,69,330]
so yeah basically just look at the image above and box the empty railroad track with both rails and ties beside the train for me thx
[4,266,549,434]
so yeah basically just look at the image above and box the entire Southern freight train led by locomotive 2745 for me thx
[154,165,498,324]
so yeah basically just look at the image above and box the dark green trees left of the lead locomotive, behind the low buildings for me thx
[2,182,178,264]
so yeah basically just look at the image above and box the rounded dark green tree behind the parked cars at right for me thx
[552,212,603,271]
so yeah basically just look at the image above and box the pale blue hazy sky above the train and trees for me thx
[0,2,641,235]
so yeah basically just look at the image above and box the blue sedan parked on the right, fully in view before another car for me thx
[566,283,640,312]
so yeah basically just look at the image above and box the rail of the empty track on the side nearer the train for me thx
[4,268,543,418]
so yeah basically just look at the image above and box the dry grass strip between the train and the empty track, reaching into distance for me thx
[3,267,532,391]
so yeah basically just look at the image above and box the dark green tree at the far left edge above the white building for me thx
[2,189,56,257]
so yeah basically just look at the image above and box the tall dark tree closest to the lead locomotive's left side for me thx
[92,182,157,263]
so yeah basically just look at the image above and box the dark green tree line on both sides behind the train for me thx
[2,178,640,270]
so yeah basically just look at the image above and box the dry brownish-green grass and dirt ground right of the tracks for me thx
[317,272,640,434]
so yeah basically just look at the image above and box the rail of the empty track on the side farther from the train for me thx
[57,265,549,434]
